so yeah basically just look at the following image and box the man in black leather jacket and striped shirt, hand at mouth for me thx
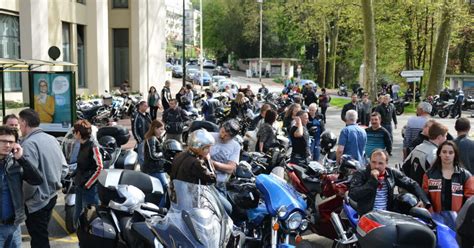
[349,149,431,216]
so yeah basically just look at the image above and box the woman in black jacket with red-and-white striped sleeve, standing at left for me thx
[72,120,103,221]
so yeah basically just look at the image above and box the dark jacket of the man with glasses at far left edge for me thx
[0,155,43,225]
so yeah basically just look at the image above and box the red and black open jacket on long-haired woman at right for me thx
[423,167,474,212]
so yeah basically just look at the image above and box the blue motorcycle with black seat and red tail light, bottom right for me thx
[331,195,459,248]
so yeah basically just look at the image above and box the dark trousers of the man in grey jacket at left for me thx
[25,196,58,248]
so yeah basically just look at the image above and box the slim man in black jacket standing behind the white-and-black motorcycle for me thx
[132,100,151,165]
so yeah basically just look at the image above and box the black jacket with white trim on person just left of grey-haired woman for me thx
[141,136,165,174]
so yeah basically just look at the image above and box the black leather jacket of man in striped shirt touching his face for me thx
[349,165,431,215]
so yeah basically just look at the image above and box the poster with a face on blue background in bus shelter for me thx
[30,72,74,132]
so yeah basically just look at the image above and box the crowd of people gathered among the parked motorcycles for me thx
[0,78,474,247]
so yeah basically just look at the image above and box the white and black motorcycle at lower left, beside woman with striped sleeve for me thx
[77,169,166,248]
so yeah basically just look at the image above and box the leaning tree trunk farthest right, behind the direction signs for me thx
[426,2,452,96]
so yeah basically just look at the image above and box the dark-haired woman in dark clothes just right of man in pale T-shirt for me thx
[257,109,276,153]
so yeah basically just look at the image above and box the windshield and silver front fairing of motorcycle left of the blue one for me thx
[166,180,233,247]
